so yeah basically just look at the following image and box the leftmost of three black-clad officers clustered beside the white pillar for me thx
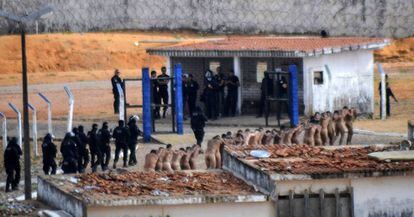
[201,72,218,120]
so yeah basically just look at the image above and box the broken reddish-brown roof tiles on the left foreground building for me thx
[77,172,254,197]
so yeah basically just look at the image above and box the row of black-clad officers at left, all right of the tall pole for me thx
[57,116,142,174]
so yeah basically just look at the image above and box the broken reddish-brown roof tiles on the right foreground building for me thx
[227,145,414,174]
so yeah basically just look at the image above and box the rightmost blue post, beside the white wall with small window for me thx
[289,65,299,126]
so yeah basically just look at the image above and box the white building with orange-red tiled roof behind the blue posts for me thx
[147,37,389,115]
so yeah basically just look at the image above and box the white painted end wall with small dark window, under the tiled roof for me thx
[303,50,374,115]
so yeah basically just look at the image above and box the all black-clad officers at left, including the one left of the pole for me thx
[4,116,142,192]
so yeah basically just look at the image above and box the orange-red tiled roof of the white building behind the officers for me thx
[147,37,390,57]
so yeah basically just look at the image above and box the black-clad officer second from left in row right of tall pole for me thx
[60,133,78,174]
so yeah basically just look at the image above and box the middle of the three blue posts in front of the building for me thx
[174,64,184,135]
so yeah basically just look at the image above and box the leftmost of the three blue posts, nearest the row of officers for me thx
[142,68,152,142]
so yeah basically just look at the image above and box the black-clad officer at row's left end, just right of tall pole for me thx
[42,134,57,175]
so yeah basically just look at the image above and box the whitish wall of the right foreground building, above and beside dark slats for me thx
[276,176,414,217]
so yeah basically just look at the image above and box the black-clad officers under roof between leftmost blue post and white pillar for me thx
[151,67,240,120]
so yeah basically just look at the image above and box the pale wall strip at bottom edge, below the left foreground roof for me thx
[88,202,276,217]
